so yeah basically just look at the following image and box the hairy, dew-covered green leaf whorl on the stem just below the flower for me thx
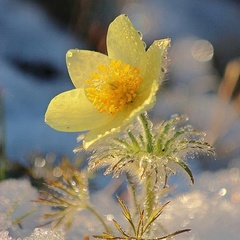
[89,115,214,185]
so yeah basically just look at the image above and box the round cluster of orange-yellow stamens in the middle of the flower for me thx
[86,60,143,115]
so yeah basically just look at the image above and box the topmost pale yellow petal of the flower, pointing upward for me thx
[107,15,145,68]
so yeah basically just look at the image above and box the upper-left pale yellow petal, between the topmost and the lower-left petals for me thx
[66,49,110,88]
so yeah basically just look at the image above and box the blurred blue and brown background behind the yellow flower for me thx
[0,0,240,178]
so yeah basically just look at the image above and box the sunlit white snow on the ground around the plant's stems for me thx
[0,168,240,240]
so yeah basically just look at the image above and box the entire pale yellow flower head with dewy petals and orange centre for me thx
[45,15,170,149]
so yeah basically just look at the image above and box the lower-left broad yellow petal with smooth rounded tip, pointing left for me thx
[45,88,111,132]
